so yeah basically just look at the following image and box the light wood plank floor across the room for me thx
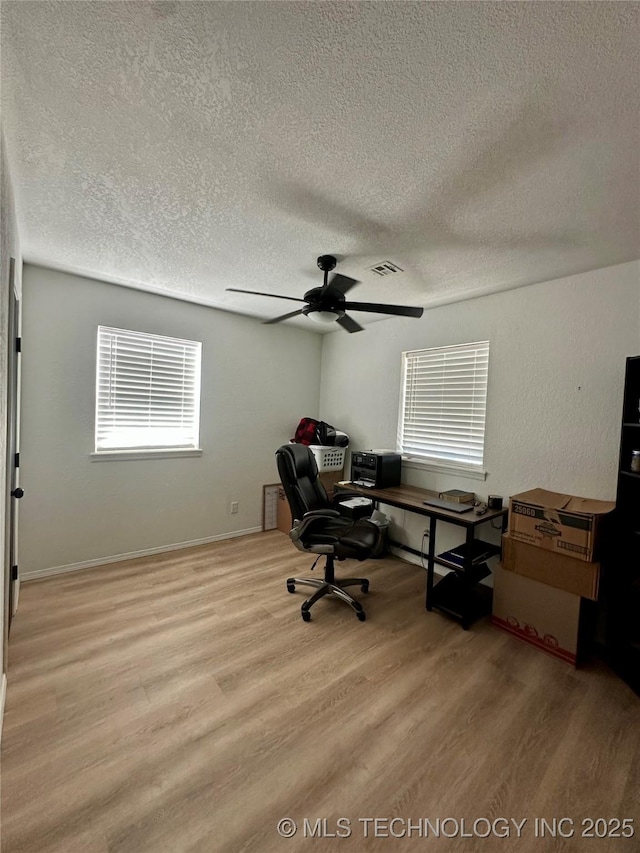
[2,531,640,853]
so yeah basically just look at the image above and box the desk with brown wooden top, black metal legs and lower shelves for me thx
[336,483,508,630]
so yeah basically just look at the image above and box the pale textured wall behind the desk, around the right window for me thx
[320,262,640,547]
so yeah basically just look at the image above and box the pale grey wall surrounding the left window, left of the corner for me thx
[20,265,321,577]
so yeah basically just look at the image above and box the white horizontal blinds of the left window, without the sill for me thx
[96,326,202,453]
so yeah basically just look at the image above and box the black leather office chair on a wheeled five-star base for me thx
[276,444,381,622]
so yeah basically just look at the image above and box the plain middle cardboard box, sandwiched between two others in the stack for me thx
[502,533,600,601]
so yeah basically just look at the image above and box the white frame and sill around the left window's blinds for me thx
[89,324,203,462]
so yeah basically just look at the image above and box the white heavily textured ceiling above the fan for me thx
[1,0,640,331]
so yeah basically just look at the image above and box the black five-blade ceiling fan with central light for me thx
[226,255,424,332]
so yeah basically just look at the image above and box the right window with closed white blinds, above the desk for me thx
[398,341,489,476]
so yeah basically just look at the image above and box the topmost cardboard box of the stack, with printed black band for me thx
[509,489,615,562]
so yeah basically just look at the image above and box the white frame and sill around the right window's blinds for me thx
[397,341,490,480]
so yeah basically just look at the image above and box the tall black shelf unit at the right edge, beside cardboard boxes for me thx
[606,356,640,695]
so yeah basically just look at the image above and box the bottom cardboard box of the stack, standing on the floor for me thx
[491,566,593,666]
